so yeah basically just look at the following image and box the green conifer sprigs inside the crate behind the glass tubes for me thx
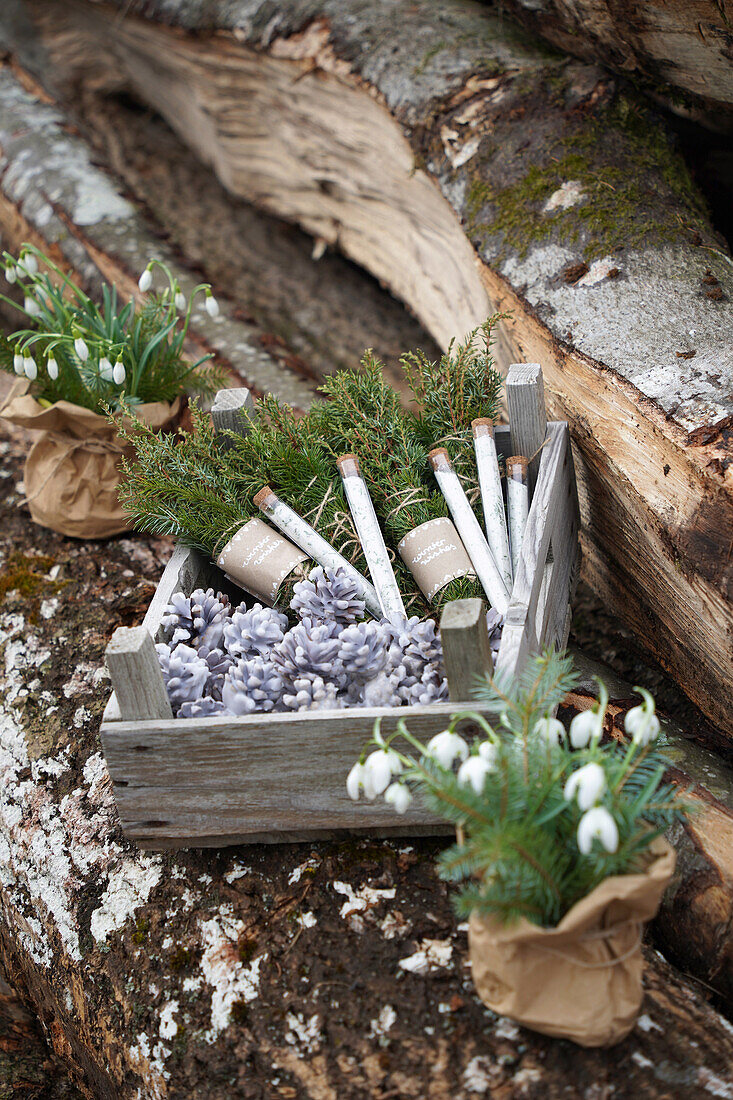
[115,318,501,615]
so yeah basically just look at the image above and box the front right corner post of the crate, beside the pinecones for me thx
[440,600,494,703]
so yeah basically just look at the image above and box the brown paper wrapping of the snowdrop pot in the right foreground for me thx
[469,838,675,1046]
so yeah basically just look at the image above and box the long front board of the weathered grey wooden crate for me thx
[101,703,490,847]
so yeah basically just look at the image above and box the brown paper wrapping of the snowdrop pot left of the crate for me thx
[0,391,180,539]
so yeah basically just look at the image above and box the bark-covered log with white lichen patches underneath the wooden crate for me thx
[0,409,733,1100]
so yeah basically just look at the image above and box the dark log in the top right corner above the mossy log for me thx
[479,0,733,131]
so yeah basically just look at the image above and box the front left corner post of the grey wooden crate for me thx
[106,626,173,722]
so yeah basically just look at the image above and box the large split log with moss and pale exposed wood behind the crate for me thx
[11,0,733,737]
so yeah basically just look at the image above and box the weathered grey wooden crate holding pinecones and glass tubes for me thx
[101,367,578,849]
